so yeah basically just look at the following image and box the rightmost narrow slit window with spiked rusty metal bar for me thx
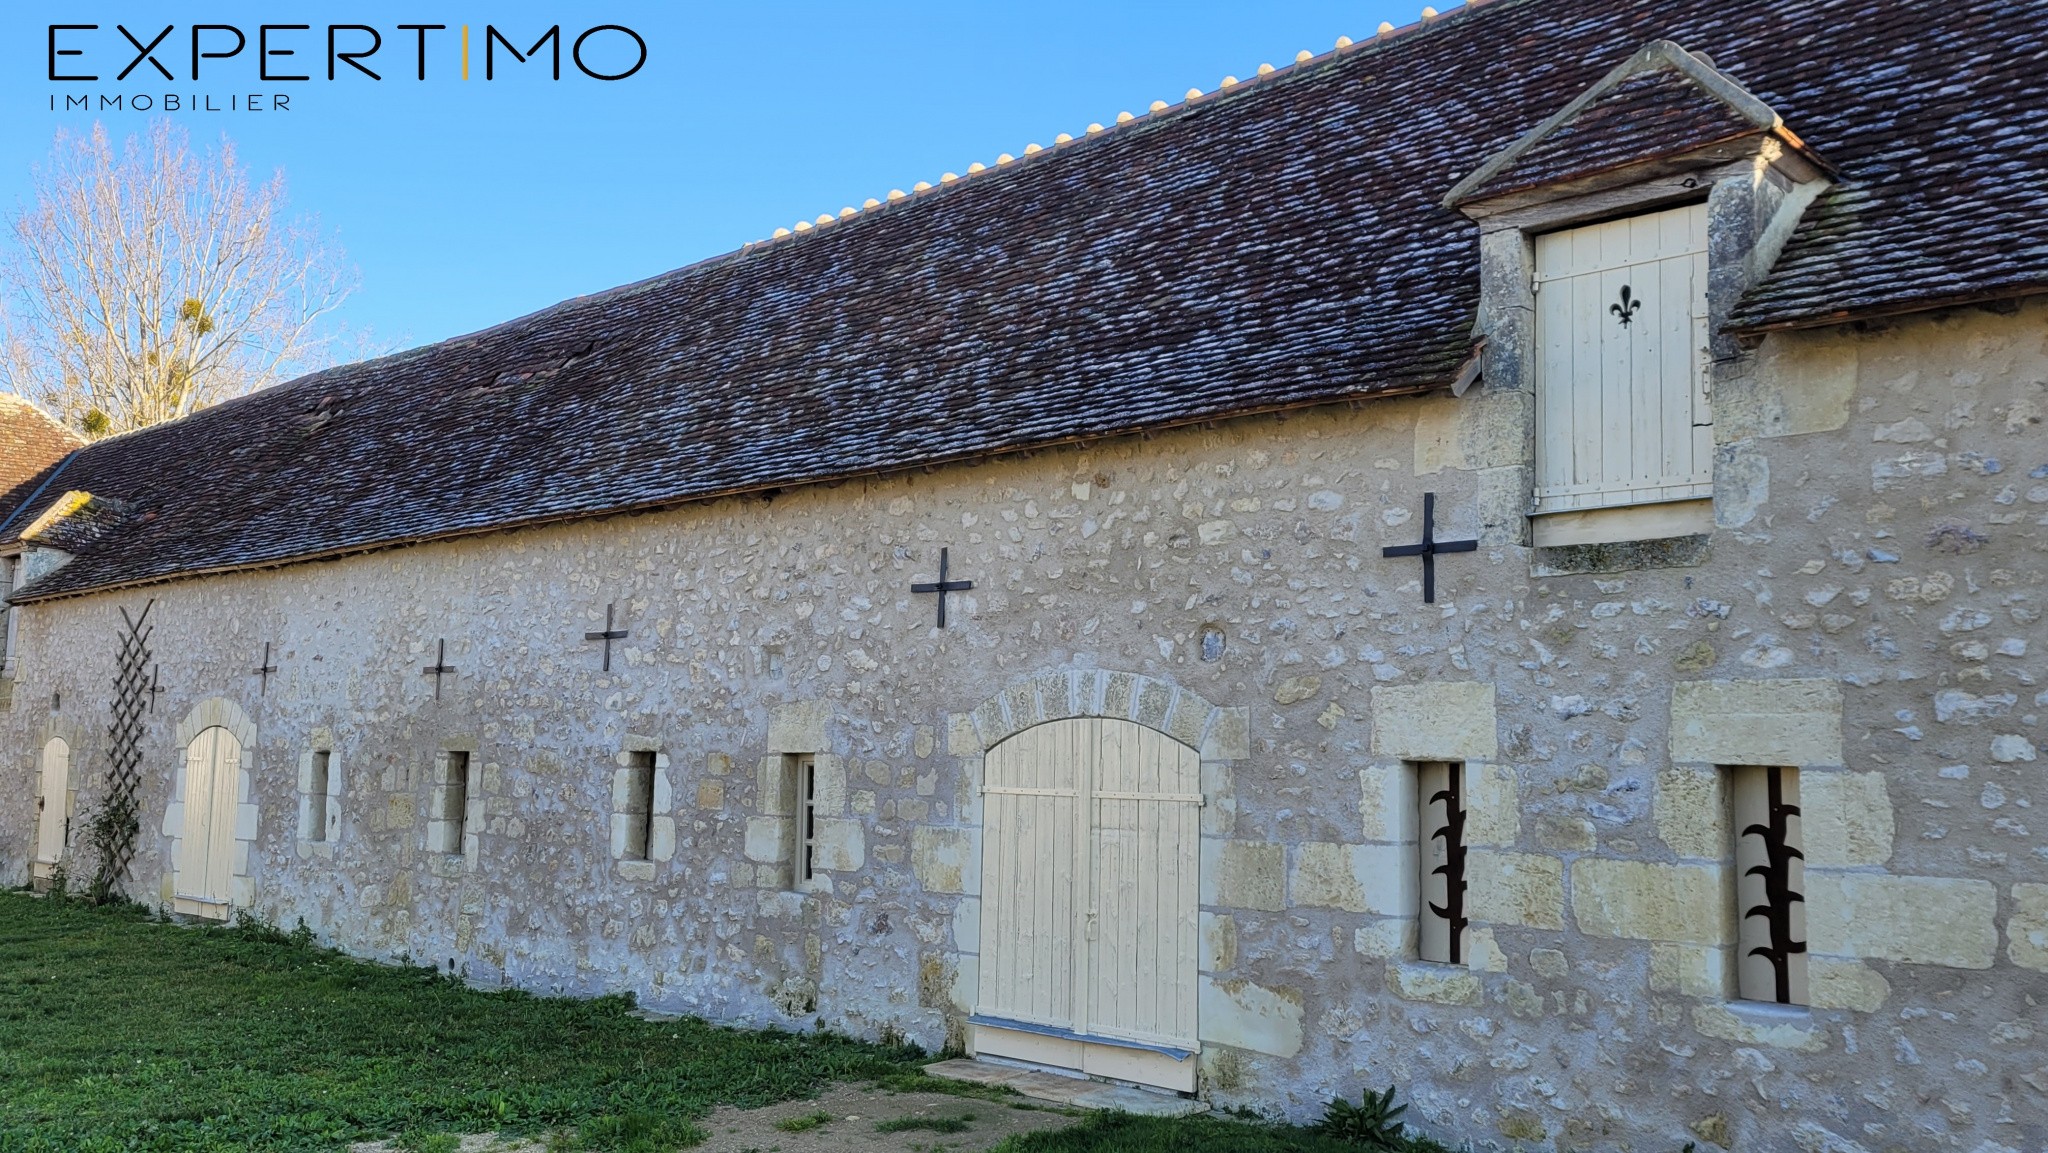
[1731,766,1808,1006]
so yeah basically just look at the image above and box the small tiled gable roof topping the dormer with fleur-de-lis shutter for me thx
[1444,41,1827,207]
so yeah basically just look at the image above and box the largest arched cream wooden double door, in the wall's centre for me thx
[975,717,1202,1092]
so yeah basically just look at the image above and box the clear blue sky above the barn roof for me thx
[0,0,1448,348]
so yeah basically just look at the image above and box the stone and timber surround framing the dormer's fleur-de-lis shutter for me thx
[1462,117,1829,552]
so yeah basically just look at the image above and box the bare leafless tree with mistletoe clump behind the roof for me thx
[0,121,354,436]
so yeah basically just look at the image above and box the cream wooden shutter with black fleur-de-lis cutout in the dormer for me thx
[1536,205,1714,512]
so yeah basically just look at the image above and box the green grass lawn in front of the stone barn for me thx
[0,893,1436,1153]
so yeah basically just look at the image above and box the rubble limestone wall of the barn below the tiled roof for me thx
[0,303,2048,1153]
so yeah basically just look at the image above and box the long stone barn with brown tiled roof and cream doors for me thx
[0,0,2048,1153]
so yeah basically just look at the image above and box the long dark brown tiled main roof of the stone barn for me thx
[4,0,2048,610]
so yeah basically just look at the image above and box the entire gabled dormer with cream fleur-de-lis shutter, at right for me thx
[1444,41,1829,552]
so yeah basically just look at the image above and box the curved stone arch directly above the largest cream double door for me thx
[952,670,1251,760]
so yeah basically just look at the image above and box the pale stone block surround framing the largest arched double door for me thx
[937,670,1253,1067]
